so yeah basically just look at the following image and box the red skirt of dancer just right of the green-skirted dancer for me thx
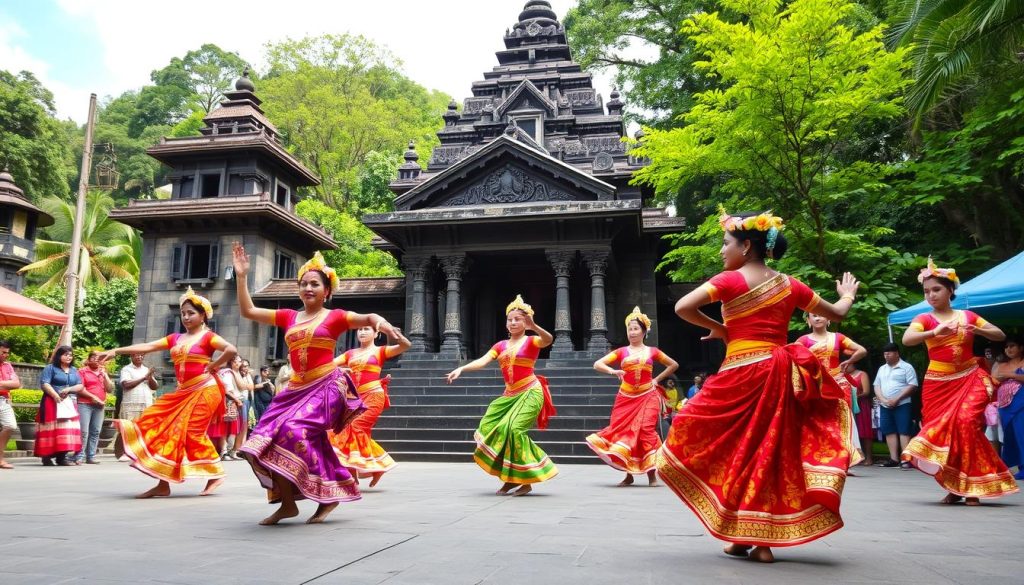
[587,386,662,473]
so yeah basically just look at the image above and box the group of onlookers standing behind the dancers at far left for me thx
[0,341,292,469]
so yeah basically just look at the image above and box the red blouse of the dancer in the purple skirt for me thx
[273,308,349,387]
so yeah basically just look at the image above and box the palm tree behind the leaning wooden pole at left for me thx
[19,191,141,289]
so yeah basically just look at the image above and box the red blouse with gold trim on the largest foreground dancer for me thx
[700,270,821,370]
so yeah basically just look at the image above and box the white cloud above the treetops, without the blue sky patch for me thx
[48,0,610,124]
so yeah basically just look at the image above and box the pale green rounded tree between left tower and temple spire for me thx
[258,35,450,211]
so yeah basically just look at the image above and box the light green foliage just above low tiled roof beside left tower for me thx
[295,199,401,278]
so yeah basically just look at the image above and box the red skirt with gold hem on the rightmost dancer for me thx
[902,367,1018,498]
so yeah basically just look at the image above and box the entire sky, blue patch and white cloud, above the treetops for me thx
[0,0,611,123]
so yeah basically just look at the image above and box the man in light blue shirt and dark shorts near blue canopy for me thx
[874,342,918,469]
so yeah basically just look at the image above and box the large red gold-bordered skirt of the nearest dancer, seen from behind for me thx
[657,345,853,546]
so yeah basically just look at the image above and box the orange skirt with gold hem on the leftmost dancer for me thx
[114,376,224,484]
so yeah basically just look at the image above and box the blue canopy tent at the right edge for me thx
[889,252,1024,340]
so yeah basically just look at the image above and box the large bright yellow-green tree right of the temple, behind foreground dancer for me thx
[636,0,920,348]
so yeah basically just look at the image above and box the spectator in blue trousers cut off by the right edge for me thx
[992,337,1024,479]
